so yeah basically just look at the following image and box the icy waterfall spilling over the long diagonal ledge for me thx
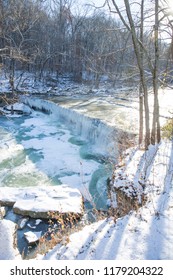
[22,96,118,158]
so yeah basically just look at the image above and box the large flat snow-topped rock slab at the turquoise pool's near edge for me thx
[0,185,83,219]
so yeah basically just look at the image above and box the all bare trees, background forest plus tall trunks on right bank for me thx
[0,0,173,149]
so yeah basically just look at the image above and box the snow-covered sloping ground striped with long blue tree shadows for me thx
[41,142,173,260]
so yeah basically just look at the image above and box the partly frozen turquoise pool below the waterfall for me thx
[0,107,111,208]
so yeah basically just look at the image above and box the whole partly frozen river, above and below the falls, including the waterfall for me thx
[0,87,171,208]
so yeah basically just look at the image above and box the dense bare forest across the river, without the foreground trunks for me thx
[0,0,172,86]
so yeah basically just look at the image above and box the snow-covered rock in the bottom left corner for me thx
[0,220,21,260]
